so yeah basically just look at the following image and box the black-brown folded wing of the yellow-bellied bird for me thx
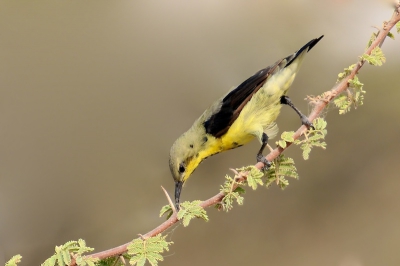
[204,60,281,138]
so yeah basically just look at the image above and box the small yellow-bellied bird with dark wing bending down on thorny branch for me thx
[169,35,324,210]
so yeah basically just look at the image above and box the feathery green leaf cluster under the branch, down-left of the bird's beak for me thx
[127,235,173,266]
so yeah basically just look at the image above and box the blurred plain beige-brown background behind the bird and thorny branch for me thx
[0,0,400,266]
